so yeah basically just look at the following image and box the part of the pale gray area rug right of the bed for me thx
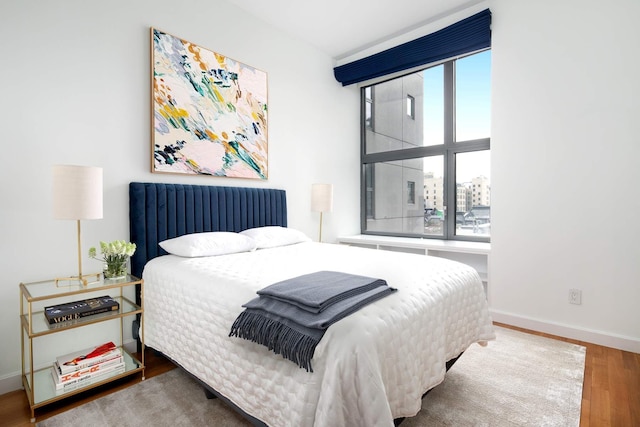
[402,328,586,427]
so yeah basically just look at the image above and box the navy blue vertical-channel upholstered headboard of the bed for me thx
[129,182,287,277]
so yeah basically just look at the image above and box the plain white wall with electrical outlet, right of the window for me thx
[490,0,640,352]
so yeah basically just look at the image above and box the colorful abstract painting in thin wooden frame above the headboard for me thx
[151,28,268,179]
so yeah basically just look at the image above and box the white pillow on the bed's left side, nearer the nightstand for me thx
[159,231,256,258]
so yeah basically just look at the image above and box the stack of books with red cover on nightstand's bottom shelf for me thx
[52,342,125,390]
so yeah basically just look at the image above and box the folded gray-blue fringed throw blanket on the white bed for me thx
[229,271,396,372]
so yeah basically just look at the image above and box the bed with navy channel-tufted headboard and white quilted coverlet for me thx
[129,182,495,427]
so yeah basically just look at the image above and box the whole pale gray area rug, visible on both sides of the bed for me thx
[37,327,585,427]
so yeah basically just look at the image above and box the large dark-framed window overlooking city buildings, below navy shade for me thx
[362,50,491,241]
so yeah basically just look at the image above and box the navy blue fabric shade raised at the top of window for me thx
[333,9,491,86]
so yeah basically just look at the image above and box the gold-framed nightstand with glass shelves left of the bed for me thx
[20,275,145,422]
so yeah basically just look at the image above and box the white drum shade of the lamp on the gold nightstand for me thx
[53,165,102,220]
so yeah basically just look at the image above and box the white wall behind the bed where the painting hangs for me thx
[0,0,360,393]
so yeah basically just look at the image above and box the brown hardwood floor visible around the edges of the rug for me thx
[0,324,640,427]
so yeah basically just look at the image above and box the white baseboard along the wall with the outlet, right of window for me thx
[489,310,640,353]
